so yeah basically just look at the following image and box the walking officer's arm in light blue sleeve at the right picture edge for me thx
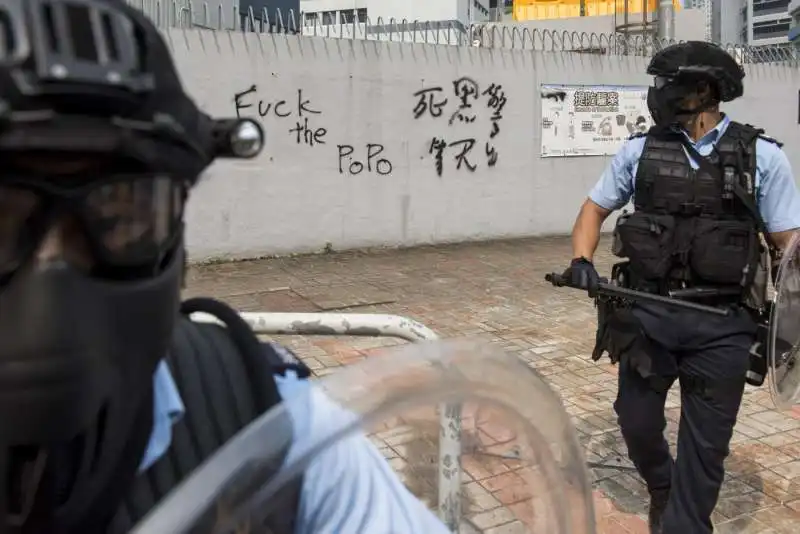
[756,140,800,249]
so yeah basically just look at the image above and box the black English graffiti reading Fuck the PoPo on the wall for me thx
[233,85,393,176]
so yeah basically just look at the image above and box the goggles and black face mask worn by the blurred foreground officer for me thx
[0,171,185,533]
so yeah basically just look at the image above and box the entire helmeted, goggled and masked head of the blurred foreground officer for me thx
[0,0,264,534]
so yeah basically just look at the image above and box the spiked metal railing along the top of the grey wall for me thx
[127,0,800,66]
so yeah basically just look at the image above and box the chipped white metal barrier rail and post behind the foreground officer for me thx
[192,312,461,534]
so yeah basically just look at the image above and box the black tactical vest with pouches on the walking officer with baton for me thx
[615,122,772,292]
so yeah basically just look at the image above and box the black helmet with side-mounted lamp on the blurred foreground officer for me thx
[0,0,264,181]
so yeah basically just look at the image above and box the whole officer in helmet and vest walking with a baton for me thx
[564,42,800,534]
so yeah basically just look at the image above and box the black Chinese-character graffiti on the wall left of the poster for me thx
[412,76,508,176]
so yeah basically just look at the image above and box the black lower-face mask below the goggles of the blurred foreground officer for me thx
[0,249,184,526]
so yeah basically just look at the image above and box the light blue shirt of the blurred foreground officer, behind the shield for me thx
[140,361,449,534]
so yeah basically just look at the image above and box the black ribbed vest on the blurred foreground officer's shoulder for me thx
[108,299,310,534]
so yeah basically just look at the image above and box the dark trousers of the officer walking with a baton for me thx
[614,305,756,534]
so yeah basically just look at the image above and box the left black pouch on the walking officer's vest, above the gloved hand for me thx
[615,211,675,280]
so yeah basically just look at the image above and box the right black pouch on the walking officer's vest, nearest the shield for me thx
[689,219,761,285]
